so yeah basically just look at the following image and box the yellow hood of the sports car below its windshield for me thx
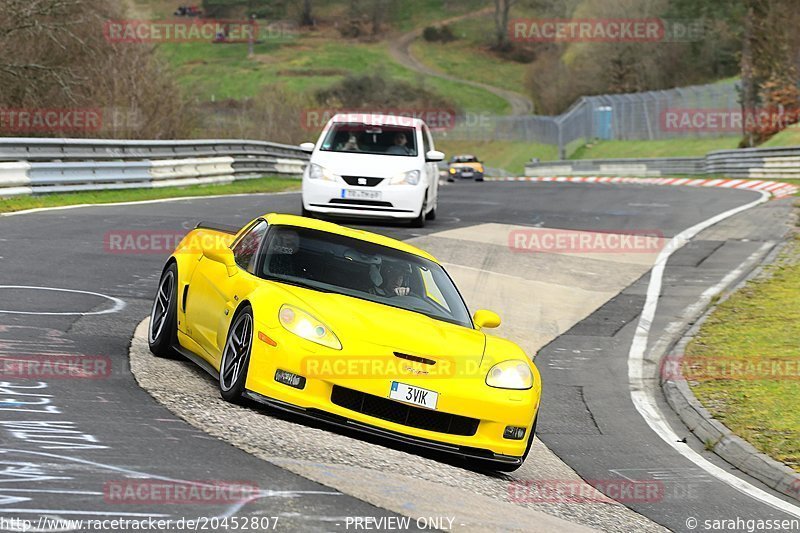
[270,282,486,364]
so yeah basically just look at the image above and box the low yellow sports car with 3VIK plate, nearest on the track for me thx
[148,214,541,471]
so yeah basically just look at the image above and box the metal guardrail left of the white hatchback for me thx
[0,138,308,197]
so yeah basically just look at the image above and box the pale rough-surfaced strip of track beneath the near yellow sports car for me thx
[130,319,666,532]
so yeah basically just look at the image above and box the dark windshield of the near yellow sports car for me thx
[259,226,472,328]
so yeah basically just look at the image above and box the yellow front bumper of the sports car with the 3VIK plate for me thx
[245,324,541,464]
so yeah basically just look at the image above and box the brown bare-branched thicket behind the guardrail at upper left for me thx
[0,0,188,138]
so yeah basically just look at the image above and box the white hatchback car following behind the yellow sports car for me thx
[300,113,444,227]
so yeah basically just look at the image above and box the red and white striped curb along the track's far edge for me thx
[486,176,800,198]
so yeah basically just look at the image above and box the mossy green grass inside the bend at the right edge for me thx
[686,235,800,472]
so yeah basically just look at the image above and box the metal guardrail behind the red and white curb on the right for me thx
[525,146,800,179]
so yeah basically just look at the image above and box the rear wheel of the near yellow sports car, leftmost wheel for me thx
[147,263,179,359]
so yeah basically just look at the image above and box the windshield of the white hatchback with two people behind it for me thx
[320,122,417,157]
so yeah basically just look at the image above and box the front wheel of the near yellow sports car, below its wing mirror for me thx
[219,305,255,403]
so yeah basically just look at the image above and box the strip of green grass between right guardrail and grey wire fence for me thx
[570,137,739,159]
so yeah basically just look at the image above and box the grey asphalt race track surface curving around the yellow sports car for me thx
[0,182,800,531]
